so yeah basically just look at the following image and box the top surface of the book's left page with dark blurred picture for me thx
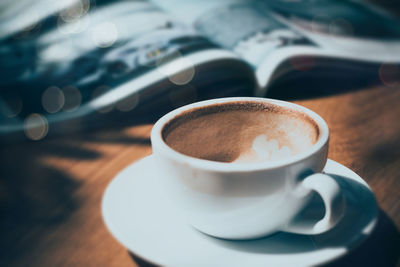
[0,0,227,117]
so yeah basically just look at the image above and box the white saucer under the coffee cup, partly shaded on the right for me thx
[102,156,378,267]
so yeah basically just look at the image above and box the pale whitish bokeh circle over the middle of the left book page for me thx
[92,22,118,48]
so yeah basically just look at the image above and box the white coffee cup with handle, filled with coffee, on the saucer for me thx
[151,97,345,239]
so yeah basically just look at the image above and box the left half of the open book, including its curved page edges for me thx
[0,0,256,140]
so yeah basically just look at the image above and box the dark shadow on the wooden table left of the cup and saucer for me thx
[0,121,150,266]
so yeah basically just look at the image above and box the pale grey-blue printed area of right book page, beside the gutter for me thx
[153,0,315,69]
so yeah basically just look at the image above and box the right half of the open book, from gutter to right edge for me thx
[153,0,400,96]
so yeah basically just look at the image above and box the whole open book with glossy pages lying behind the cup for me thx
[0,0,400,140]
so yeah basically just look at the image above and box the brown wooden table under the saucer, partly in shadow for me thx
[0,82,400,267]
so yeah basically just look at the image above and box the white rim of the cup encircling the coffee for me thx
[150,97,329,172]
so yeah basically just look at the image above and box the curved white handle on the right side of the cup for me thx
[283,173,346,235]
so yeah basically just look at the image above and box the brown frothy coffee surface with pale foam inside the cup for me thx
[163,102,319,162]
